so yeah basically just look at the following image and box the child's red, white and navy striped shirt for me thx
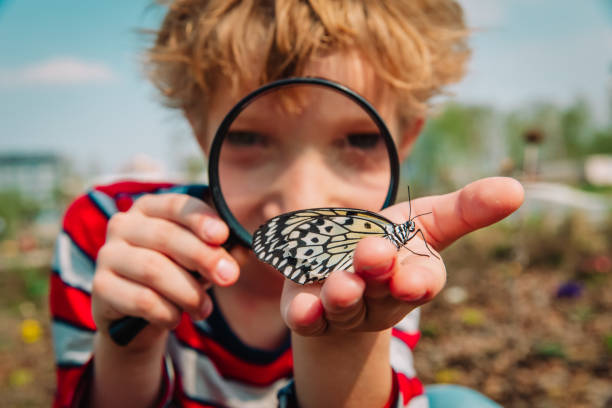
[50,182,427,408]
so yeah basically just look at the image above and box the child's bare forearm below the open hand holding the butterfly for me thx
[292,330,392,408]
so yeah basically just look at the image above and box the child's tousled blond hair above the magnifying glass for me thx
[147,0,470,133]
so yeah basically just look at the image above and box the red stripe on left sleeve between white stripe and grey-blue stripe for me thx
[49,273,96,330]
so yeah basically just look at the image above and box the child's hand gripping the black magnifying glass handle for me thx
[92,194,239,349]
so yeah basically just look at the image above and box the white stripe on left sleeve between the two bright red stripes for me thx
[53,232,95,293]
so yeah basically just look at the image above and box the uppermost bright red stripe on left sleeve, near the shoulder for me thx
[63,195,107,259]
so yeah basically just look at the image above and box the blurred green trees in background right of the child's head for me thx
[402,99,612,195]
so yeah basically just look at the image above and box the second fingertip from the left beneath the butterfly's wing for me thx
[320,271,366,330]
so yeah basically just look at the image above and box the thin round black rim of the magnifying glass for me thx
[208,77,399,248]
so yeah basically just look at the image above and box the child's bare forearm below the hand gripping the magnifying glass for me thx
[87,333,166,408]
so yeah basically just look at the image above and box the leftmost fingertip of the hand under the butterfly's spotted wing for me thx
[281,279,327,336]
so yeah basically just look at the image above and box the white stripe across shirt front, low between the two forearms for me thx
[168,335,289,408]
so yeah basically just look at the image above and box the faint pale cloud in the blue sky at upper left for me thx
[0,57,114,86]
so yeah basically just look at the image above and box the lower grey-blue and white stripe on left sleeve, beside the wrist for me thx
[51,321,95,365]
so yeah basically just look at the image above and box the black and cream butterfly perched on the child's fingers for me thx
[253,190,438,285]
